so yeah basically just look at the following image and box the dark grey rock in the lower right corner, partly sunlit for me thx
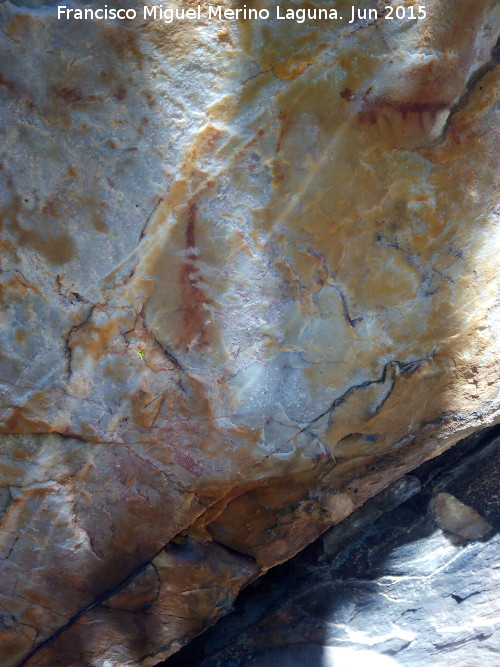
[164,429,500,667]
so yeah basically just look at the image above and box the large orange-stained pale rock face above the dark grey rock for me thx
[0,0,500,667]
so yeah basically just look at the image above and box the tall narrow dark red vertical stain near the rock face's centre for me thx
[179,204,210,351]
